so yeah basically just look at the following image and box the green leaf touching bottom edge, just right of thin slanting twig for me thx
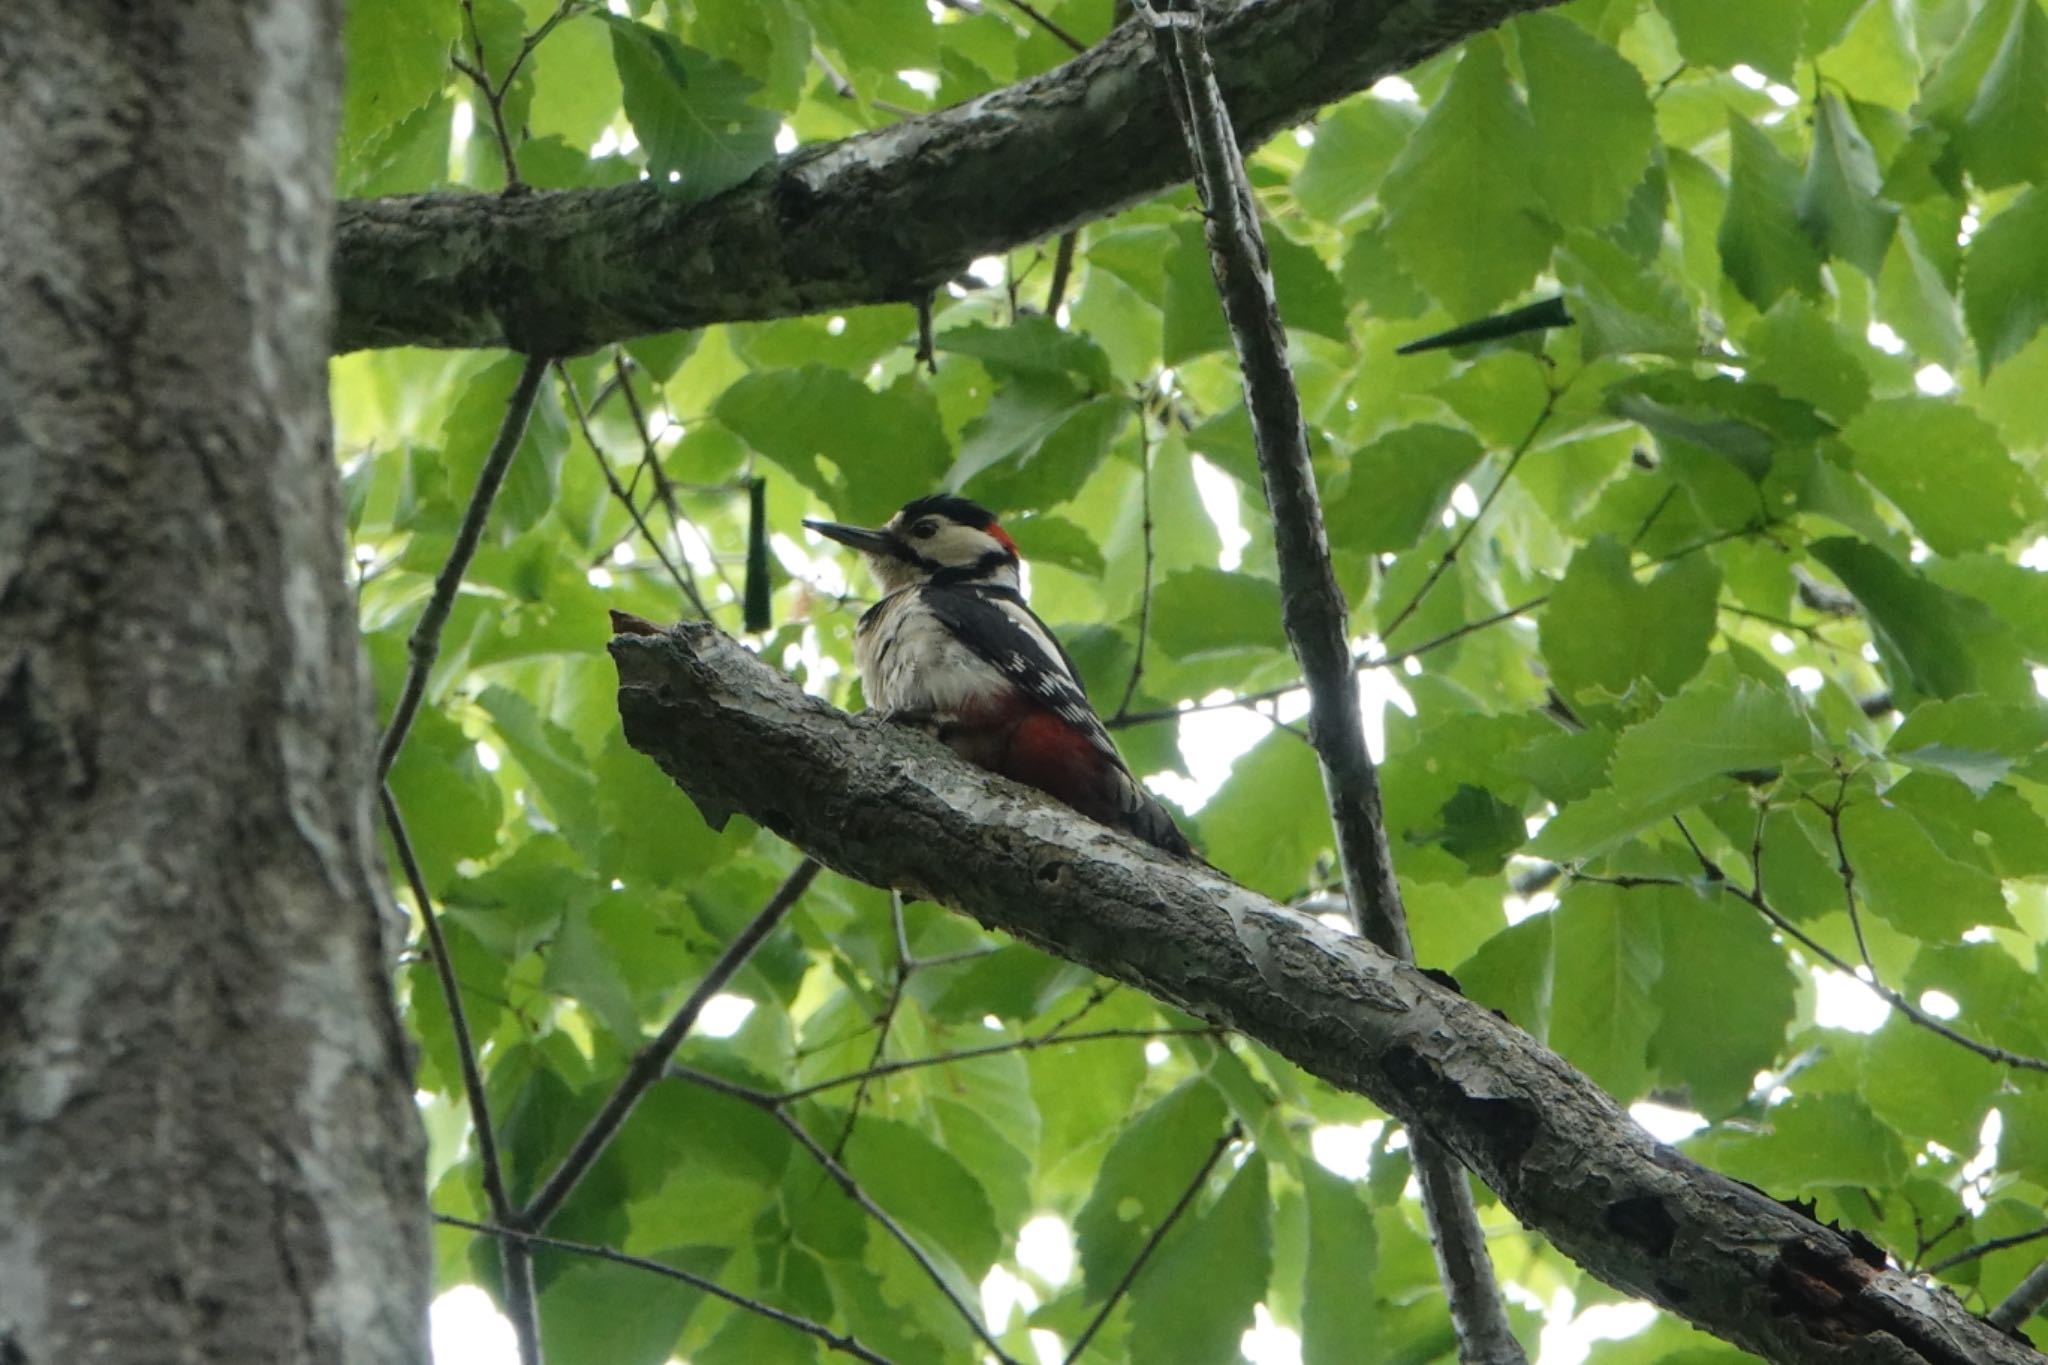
[1130,1154,1274,1365]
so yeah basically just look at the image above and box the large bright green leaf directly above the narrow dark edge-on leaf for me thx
[1380,35,1554,317]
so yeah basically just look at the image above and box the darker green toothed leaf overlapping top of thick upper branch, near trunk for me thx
[606,14,780,201]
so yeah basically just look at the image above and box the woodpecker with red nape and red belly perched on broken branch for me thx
[805,493,1194,857]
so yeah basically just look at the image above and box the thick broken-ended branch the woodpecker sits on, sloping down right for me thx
[612,626,2044,1365]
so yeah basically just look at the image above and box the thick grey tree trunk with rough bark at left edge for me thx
[0,0,430,1365]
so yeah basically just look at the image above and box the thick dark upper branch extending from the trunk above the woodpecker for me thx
[336,0,1561,356]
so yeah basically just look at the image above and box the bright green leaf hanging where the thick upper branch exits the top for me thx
[1516,14,1657,227]
